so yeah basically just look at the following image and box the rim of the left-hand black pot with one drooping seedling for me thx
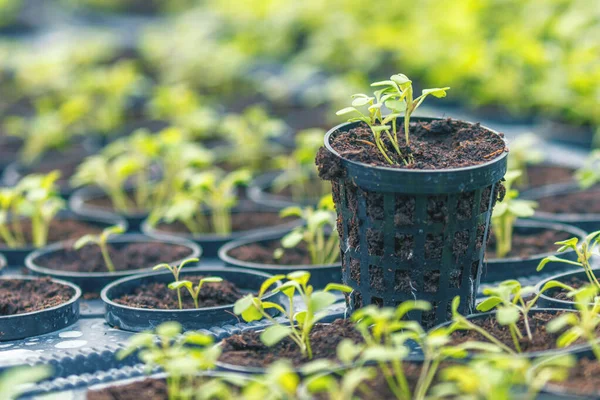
[25,233,202,279]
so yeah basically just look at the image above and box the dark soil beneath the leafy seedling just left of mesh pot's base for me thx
[219,319,363,367]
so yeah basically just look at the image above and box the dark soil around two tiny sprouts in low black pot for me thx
[113,275,244,310]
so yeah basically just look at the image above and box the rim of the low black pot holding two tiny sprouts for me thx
[100,266,282,314]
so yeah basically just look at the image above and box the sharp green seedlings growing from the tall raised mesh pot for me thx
[337,74,450,165]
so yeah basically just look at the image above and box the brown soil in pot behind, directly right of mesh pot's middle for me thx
[485,229,572,260]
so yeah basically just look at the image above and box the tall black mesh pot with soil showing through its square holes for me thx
[318,118,507,327]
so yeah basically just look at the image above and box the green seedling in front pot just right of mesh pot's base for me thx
[476,280,571,353]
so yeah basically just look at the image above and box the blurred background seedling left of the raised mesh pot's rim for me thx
[221,106,285,172]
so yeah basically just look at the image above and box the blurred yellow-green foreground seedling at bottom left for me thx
[117,322,221,400]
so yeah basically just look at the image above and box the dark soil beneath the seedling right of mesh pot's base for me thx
[452,311,600,353]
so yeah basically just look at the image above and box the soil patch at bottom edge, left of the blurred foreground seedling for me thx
[86,379,169,400]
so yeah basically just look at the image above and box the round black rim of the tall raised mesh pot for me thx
[324,116,508,175]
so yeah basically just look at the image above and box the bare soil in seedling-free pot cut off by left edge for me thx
[0,278,75,316]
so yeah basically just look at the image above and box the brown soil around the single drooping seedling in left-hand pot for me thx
[35,242,192,272]
